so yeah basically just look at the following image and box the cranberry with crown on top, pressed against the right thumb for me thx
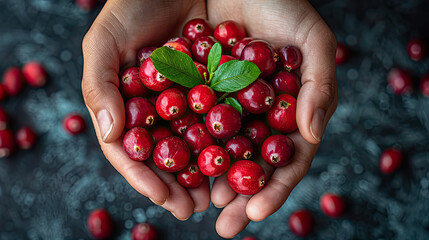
[267,94,298,133]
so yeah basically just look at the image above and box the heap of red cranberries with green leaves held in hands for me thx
[120,19,302,195]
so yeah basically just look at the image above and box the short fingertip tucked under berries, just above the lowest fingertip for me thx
[211,174,237,208]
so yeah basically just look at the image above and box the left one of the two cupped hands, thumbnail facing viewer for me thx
[82,0,210,220]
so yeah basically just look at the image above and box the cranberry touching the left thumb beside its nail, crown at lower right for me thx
[125,97,158,129]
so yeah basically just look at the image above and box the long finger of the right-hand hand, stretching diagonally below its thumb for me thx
[246,132,318,221]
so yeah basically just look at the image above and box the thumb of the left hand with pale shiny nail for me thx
[82,24,125,143]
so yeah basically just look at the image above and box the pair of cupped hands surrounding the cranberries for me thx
[82,0,337,238]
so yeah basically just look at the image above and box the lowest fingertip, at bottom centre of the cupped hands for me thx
[216,195,250,238]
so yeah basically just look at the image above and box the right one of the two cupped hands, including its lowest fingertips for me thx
[207,0,338,238]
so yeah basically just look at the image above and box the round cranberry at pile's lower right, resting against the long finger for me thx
[261,134,295,167]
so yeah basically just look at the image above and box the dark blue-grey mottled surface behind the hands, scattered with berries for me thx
[0,0,429,239]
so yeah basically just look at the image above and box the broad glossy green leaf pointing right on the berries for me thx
[210,60,261,92]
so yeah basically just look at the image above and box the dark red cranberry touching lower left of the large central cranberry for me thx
[183,123,216,157]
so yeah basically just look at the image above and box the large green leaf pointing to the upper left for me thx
[150,47,204,88]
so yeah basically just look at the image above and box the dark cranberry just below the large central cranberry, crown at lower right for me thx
[225,135,253,160]
